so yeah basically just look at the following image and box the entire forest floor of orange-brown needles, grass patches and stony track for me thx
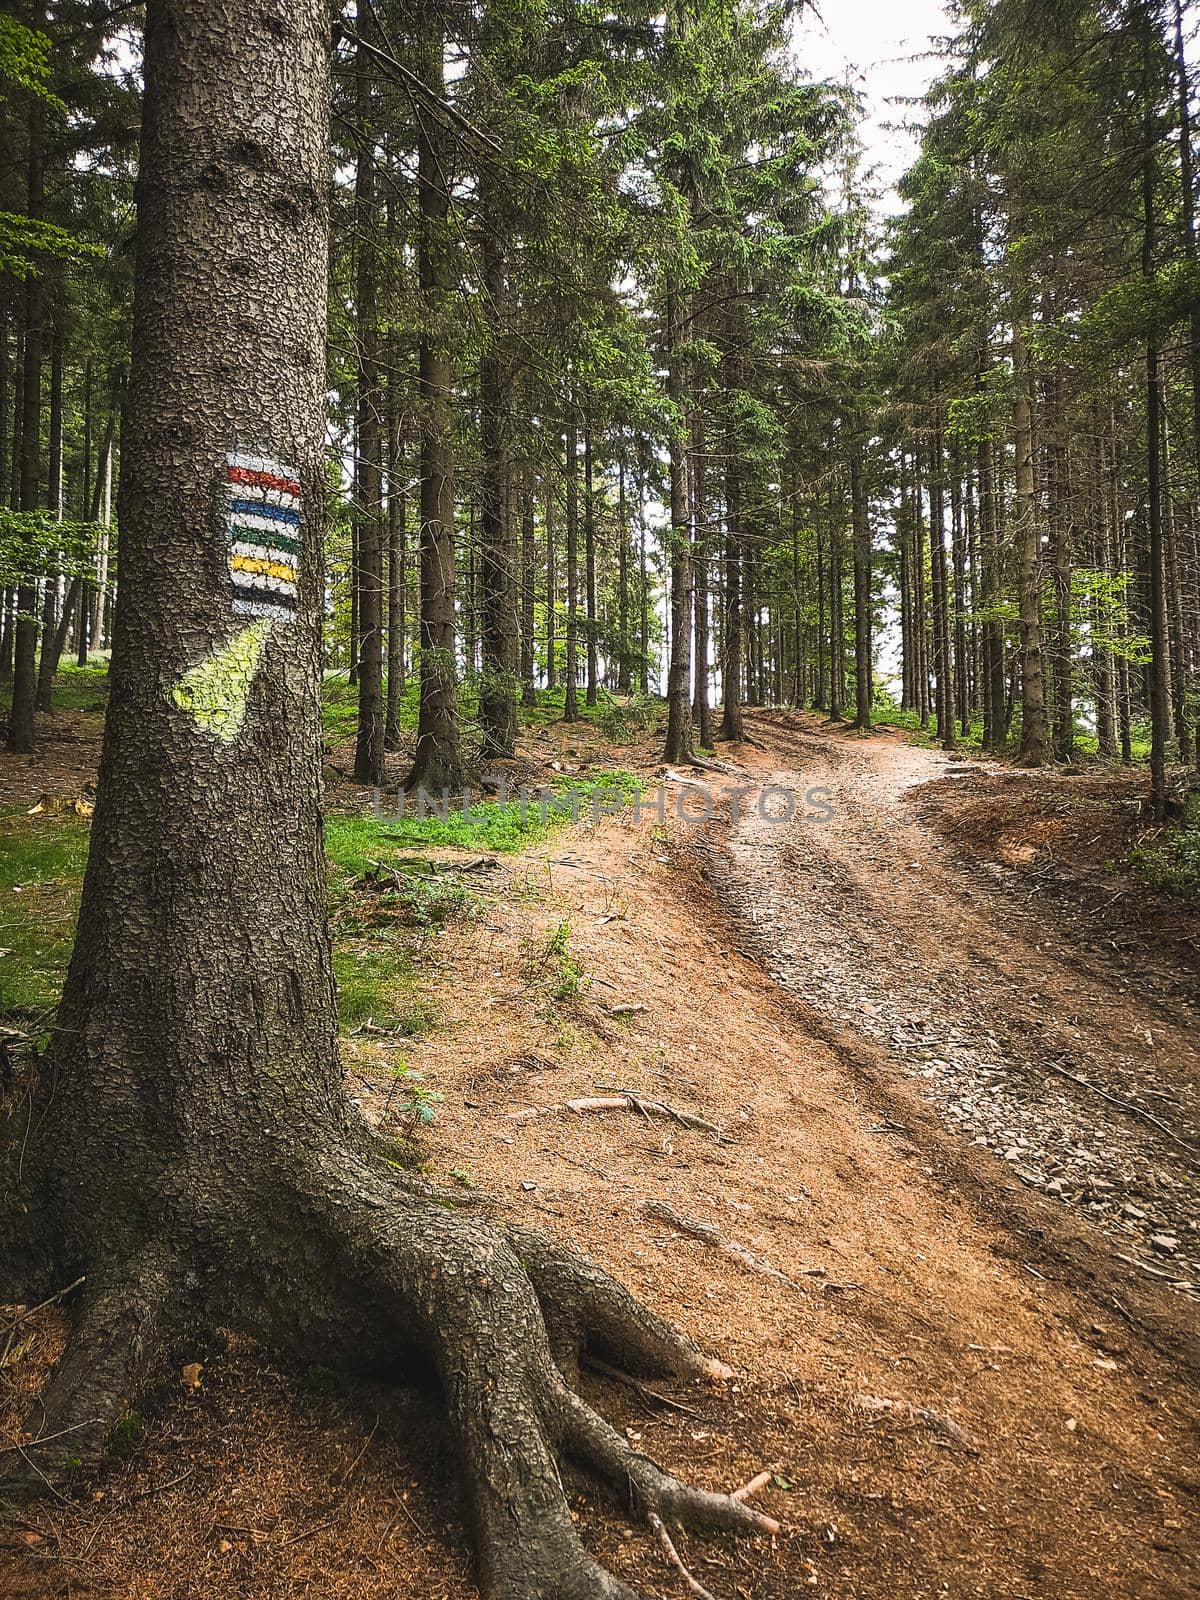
[0,672,1200,1600]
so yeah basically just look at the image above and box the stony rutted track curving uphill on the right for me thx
[717,712,1200,1320]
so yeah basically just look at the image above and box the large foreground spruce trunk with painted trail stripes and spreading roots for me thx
[0,12,778,1600]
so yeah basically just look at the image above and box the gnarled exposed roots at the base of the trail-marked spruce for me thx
[0,1147,778,1600]
